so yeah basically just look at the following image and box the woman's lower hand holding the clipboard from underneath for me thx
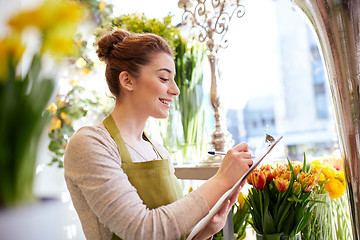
[194,184,244,240]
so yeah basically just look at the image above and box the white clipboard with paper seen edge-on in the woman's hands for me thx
[187,136,283,240]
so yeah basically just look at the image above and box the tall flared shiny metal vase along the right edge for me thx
[293,0,360,240]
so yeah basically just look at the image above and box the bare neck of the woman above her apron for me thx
[111,102,148,142]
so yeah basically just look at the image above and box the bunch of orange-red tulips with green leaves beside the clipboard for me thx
[246,154,321,239]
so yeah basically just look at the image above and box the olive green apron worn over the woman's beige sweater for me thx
[103,115,183,240]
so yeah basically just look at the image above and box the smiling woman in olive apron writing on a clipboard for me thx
[64,30,252,240]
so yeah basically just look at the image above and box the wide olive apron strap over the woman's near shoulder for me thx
[103,114,131,163]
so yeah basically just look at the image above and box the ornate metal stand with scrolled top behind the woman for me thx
[179,0,245,165]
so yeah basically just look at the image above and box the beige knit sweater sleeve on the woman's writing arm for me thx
[64,127,209,239]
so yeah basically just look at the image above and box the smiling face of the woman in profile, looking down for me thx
[131,53,180,118]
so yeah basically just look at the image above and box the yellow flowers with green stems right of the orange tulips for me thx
[303,153,352,240]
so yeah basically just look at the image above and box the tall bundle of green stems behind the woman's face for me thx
[175,41,207,162]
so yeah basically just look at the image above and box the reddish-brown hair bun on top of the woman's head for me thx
[96,30,130,63]
